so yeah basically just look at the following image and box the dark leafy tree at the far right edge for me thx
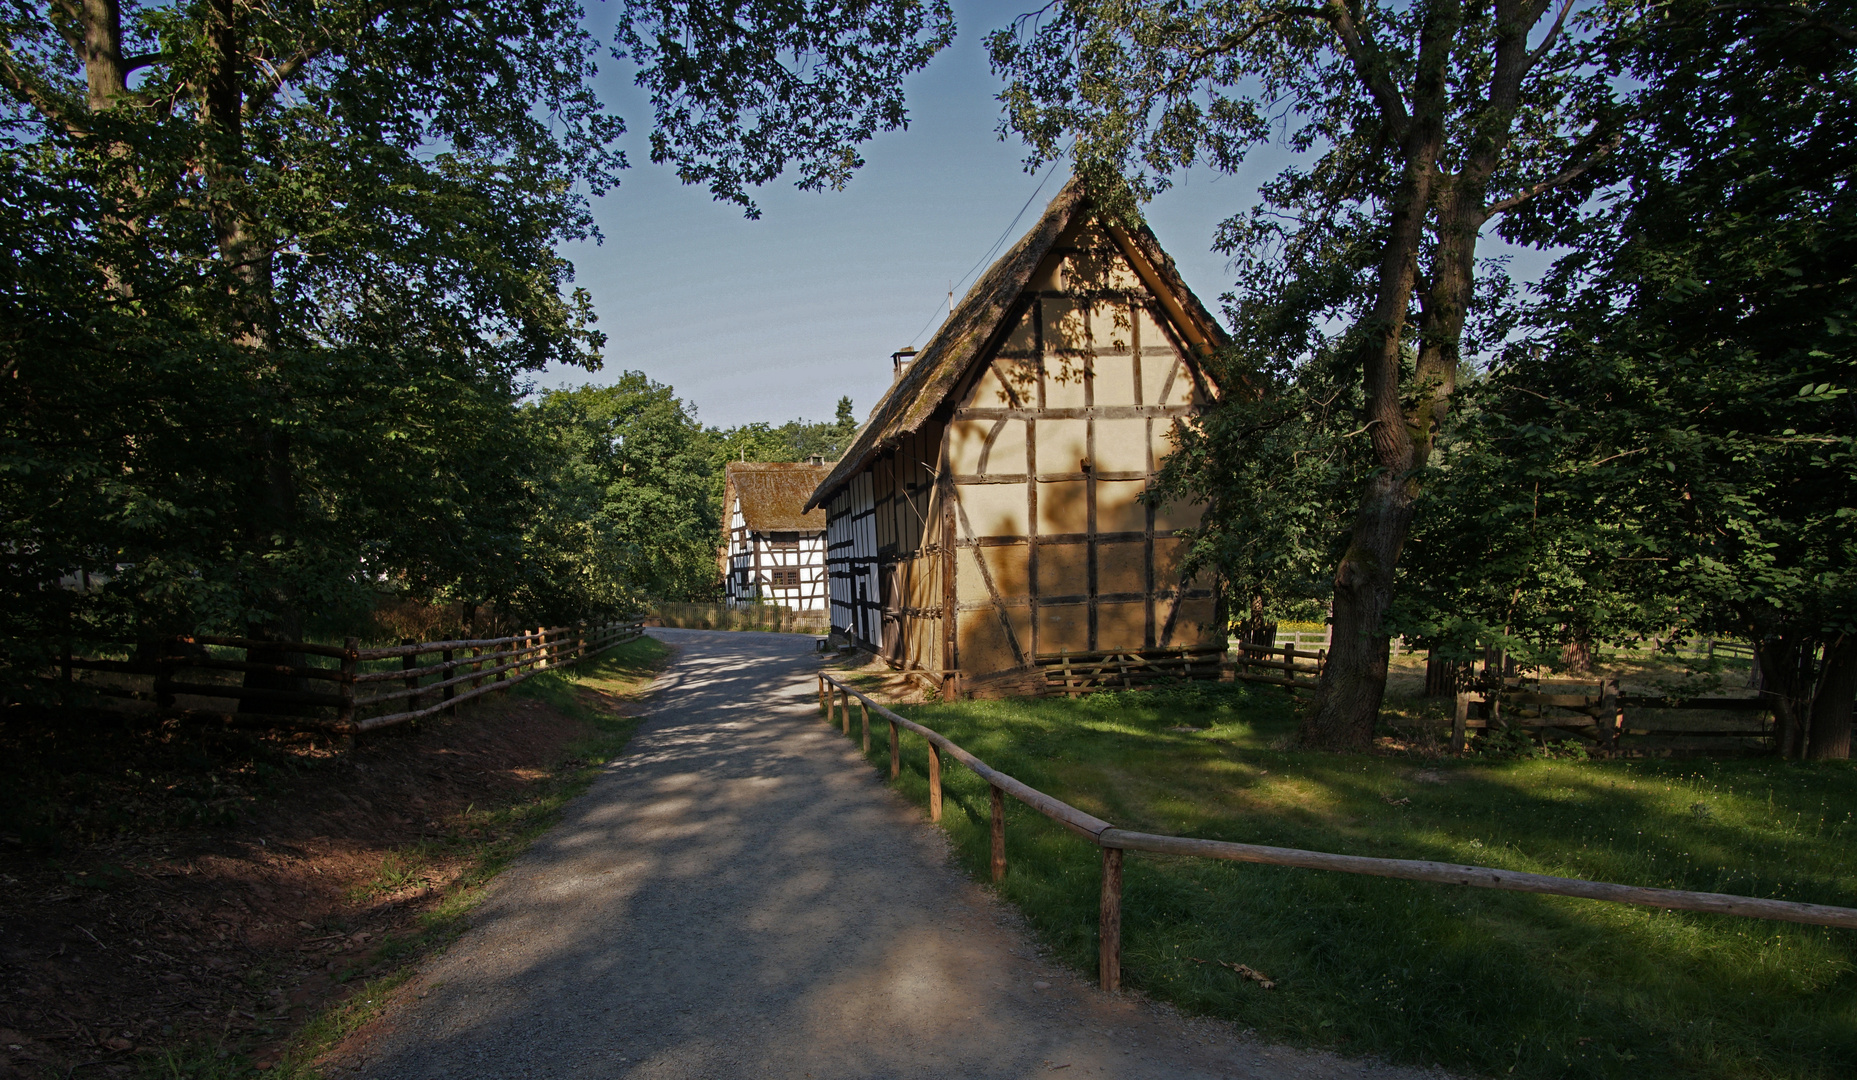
[1443,0,1857,757]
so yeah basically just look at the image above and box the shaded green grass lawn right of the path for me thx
[839,683,1857,1078]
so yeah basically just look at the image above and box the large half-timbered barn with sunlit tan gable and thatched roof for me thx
[808,182,1226,696]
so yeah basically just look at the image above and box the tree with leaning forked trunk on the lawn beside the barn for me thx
[993,0,1617,748]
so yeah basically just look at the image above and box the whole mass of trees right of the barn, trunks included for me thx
[992,0,1857,746]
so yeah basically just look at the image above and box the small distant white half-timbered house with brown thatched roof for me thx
[722,462,830,611]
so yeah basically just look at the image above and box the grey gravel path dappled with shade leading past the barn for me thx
[349,629,1448,1080]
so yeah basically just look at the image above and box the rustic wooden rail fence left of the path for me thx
[52,618,643,735]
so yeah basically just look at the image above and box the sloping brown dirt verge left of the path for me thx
[0,656,661,1076]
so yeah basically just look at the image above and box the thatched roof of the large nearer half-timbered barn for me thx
[806,180,1227,510]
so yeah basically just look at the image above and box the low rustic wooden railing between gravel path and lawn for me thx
[819,672,1857,991]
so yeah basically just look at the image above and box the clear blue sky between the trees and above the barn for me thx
[537,4,1263,427]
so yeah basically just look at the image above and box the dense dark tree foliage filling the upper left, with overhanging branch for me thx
[0,0,953,686]
